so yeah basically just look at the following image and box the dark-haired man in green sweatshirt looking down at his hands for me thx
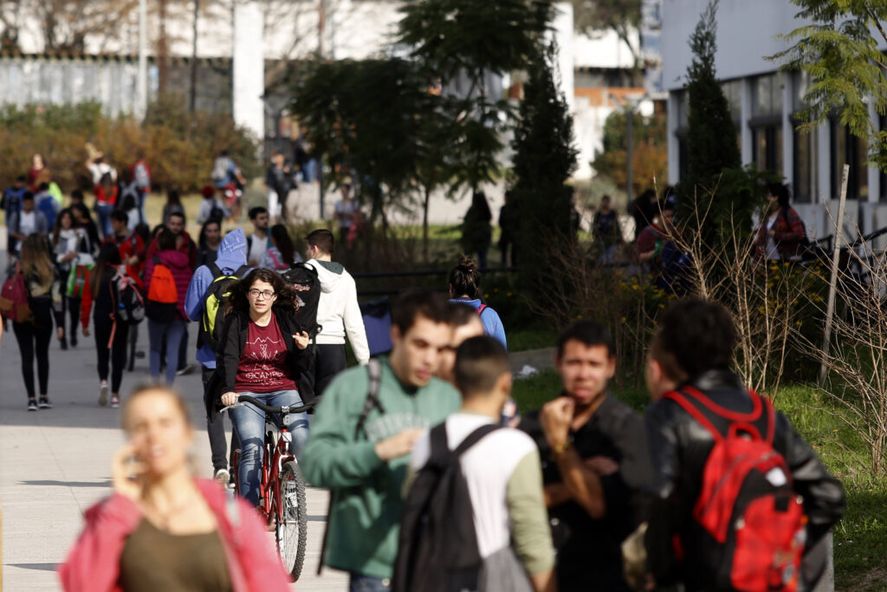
[301,291,459,592]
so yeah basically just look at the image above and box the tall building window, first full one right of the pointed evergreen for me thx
[749,74,782,175]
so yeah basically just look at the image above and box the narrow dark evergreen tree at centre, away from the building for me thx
[512,43,577,300]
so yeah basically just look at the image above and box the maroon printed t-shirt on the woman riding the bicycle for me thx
[234,315,297,393]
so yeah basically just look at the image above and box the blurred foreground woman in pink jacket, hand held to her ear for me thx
[59,386,289,592]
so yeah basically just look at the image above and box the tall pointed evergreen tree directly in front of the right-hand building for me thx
[678,0,758,249]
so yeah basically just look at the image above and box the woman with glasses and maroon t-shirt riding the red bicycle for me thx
[218,269,309,505]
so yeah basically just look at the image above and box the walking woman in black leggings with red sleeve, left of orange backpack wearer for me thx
[80,244,129,407]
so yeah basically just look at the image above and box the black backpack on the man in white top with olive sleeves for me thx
[391,422,501,592]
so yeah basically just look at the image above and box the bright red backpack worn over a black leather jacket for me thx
[664,387,807,592]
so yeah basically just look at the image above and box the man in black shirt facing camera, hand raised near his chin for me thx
[518,321,649,592]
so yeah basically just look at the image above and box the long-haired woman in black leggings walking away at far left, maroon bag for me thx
[6,234,61,411]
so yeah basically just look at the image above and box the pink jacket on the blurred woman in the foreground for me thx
[59,479,290,592]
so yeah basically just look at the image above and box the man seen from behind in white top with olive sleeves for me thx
[408,336,555,592]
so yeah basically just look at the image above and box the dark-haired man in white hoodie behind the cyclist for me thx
[305,228,370,396]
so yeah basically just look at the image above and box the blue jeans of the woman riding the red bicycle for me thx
[231,391,308,506]
